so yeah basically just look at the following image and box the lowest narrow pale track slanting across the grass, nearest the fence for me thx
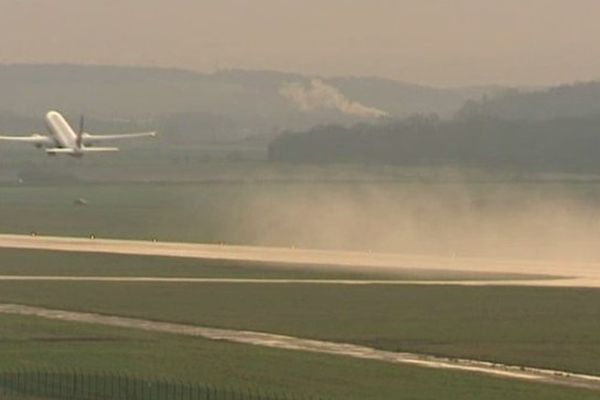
[0,304,600,390]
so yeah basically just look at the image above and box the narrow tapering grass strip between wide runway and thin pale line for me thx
[0,248,543,280]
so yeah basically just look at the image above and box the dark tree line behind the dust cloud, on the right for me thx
[269,114,600,172]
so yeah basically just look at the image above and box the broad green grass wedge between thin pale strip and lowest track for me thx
[0,282,600,374]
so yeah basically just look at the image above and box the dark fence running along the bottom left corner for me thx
[0,370,324,400]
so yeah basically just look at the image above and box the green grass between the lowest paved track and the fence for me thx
[0,316,598,400]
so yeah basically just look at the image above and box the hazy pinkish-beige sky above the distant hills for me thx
[0,0,600,86]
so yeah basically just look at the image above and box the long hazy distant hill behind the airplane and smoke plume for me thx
[0,65,495,143]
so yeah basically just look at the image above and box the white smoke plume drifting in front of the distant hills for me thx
[279,79,388,118]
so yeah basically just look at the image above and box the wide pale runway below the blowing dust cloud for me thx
[0,235,600,288]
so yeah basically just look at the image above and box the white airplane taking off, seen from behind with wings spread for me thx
[0,111,156,157]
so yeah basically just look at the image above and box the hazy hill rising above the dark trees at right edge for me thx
[458,82,600,120]
